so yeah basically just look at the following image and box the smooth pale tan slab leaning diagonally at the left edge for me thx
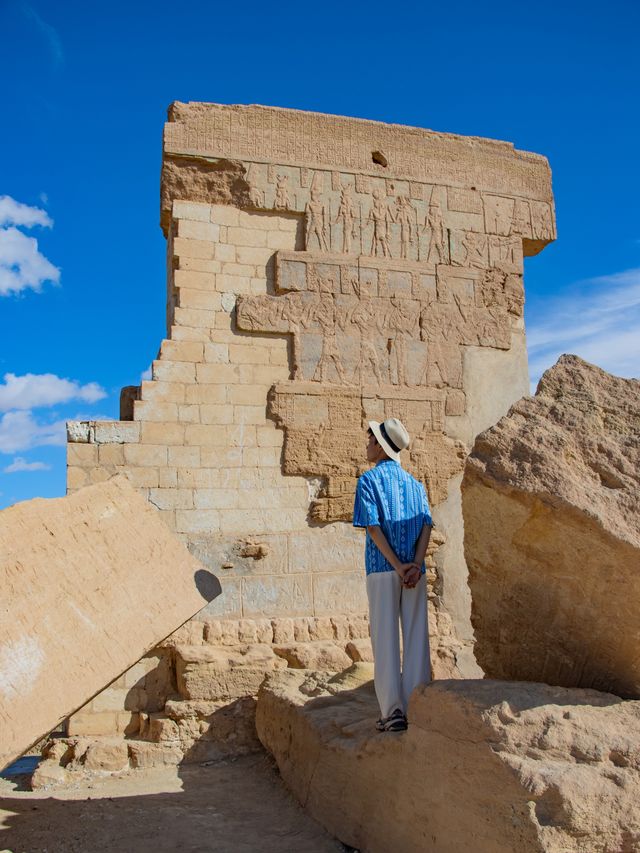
[0,478,219,767]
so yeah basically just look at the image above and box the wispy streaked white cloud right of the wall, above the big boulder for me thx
[527,268,640,387]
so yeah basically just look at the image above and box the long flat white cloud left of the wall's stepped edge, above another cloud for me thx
[0,373,107,412]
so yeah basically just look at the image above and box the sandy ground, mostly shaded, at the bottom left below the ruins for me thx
[0,754,350,853]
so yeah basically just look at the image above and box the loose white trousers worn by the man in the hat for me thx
[367,572,431,717]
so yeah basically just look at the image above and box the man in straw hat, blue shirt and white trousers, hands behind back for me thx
[353,418,433,732]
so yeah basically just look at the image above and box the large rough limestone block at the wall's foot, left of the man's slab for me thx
[176,644,286,701]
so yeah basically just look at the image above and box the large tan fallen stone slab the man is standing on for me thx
[256,664,640,853]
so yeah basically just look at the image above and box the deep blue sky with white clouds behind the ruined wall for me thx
[0,0,640,507]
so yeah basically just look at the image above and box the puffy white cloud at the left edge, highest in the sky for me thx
[0,195,60,296]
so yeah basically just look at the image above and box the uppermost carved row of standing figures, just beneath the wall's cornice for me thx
[246,163,555,258]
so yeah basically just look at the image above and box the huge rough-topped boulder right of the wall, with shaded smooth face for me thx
[462,355,640,698]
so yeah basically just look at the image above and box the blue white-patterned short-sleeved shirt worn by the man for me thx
[353,459,433,575]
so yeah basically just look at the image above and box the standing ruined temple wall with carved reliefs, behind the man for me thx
[68,103,555,744]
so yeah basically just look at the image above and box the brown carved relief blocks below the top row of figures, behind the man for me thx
[236,252,522,520]
